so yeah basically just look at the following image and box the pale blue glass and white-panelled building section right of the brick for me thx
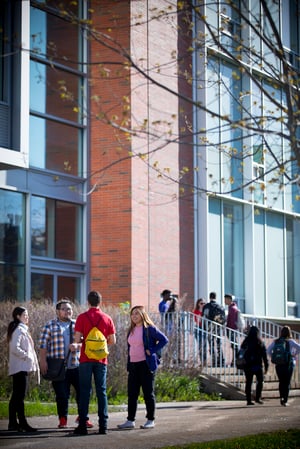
[194,0,300,319]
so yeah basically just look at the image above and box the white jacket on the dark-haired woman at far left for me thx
[8,323,39,377]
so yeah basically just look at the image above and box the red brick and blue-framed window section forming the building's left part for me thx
[0,0,194,310]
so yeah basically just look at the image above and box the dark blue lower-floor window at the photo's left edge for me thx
[0,190,25,301]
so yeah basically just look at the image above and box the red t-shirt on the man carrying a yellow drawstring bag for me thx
[75,307,116,365]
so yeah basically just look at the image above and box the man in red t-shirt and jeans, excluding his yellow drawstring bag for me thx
[74,291,116,435]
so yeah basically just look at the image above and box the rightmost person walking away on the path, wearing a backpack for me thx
[267,326,300,407]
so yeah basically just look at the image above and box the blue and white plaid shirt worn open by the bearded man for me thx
[39,319,80,367]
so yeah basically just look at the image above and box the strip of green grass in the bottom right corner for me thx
[163,429,300,449]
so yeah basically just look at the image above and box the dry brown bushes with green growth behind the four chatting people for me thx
[0,301,211,404]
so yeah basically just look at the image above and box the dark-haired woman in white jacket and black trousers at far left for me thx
[7,307,39,432]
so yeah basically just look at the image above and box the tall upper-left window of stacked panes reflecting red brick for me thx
[29,0,85,176]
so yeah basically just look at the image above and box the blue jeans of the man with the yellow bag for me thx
[79,362,108,429]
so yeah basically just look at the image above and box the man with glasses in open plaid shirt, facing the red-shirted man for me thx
[40,299,93,429]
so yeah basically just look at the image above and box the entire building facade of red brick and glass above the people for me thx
[0,0,300,319]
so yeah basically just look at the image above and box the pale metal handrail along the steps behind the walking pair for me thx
[151,312,300,388]
